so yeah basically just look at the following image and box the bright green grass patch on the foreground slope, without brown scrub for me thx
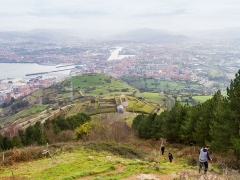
[0,143,193,180]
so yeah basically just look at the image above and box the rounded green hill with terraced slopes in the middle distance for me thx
[0,74,162,134]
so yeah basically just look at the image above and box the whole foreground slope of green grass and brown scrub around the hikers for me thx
[0,141,239,180]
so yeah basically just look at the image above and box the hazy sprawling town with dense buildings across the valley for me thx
[0,29,240,103]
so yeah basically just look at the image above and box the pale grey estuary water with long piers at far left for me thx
[0,63,74,79]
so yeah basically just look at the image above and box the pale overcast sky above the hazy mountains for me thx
[0,0,240,31]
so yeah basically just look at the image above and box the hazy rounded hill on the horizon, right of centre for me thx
[111,28,188,43]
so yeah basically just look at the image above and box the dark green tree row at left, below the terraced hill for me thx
[0,113,91,152]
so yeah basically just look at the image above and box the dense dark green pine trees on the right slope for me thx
[132,70,240,158]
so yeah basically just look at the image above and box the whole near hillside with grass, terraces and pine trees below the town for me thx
[0,72,240,180]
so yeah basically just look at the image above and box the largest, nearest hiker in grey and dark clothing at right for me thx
[199,145,212,174]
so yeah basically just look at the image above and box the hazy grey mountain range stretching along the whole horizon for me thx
[0,27,240,43]
